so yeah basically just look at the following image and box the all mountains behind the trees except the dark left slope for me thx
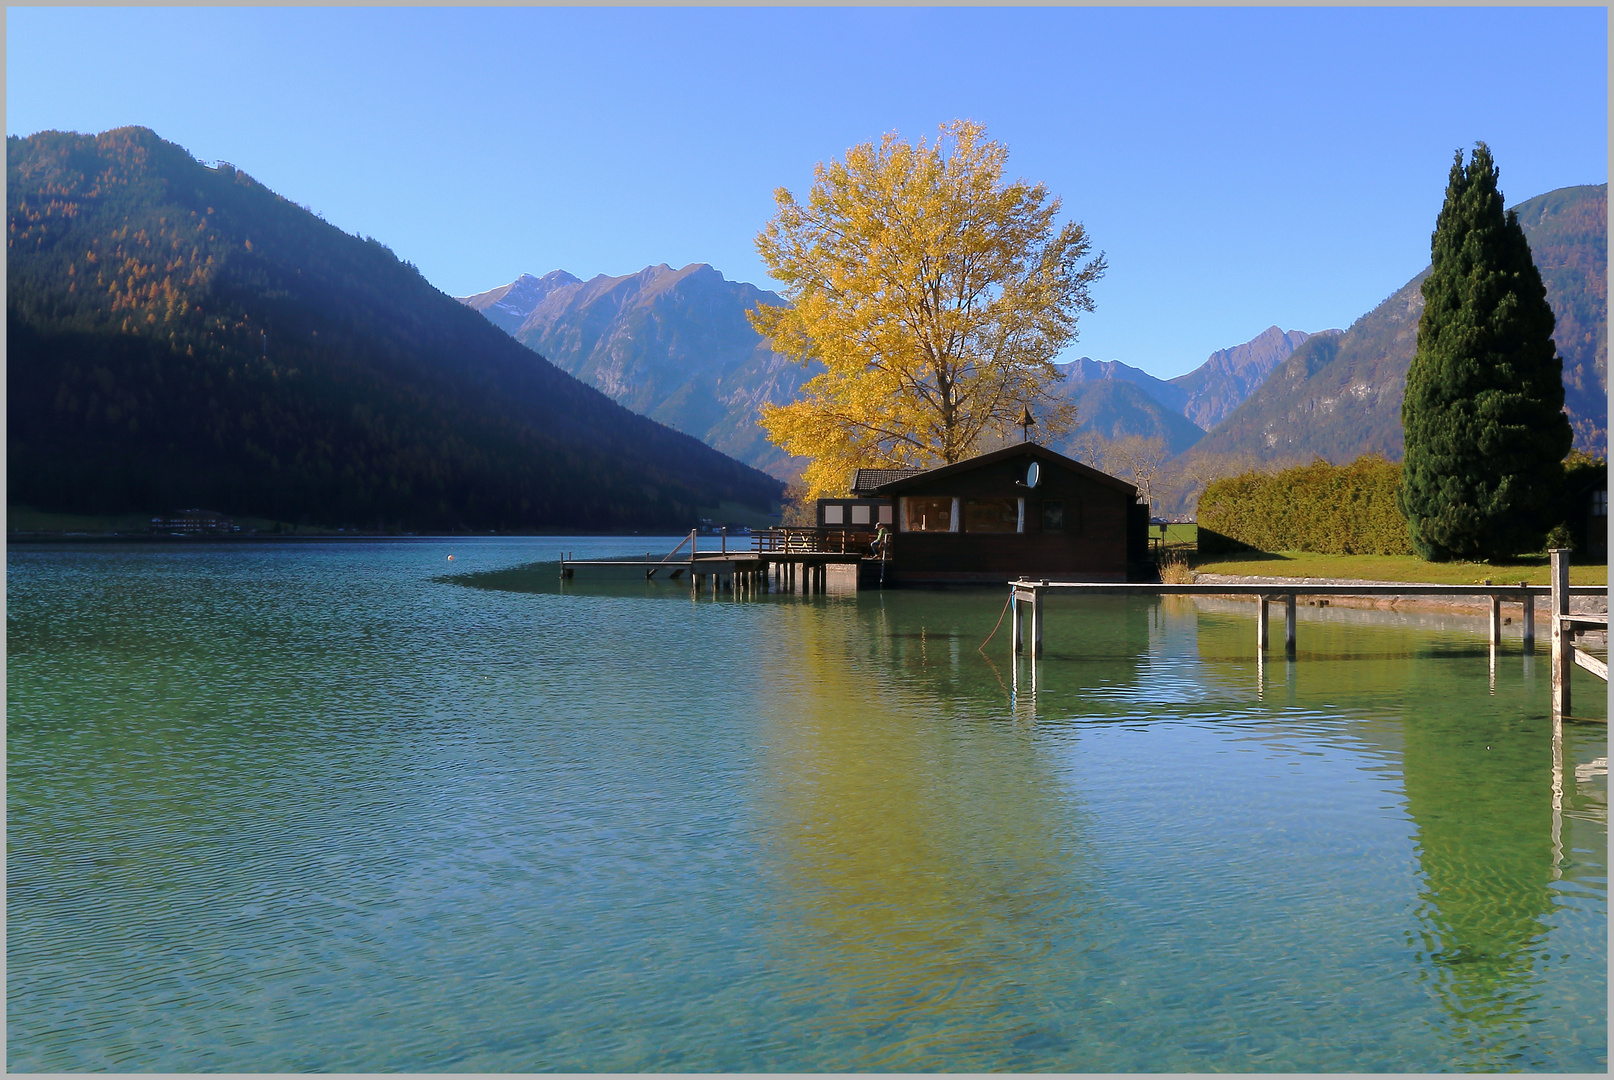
[462,184,1608,493]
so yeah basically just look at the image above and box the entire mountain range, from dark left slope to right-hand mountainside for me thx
[18,128,1608,530]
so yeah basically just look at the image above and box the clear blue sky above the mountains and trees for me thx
[6,6,1608,378]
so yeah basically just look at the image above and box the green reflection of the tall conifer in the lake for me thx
[1403,686,1556,1069]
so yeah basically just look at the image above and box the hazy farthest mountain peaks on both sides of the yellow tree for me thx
[460,263,1336,479]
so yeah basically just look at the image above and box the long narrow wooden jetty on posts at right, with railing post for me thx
[1009,550,1609,717]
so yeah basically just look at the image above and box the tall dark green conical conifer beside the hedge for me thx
[1396,142,1574,562]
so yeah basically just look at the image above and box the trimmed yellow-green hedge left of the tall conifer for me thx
[1198,454,1412,555]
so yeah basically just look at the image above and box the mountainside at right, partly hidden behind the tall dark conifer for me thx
[1191,184,1608,463]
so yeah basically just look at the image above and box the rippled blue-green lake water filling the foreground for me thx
[6,538,1608,1072]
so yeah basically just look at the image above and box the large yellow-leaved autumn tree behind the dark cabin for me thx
[749,121,1104,496]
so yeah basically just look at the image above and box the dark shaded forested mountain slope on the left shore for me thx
[6,128,781,530]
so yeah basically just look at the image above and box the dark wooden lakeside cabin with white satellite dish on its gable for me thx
[818,442,1149,584]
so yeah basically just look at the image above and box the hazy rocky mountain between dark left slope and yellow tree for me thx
[460,263,813,478]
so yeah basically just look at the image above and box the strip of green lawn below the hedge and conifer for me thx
[1194,552,1609,584]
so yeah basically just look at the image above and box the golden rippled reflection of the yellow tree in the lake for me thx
[748,596,1129,1070]
